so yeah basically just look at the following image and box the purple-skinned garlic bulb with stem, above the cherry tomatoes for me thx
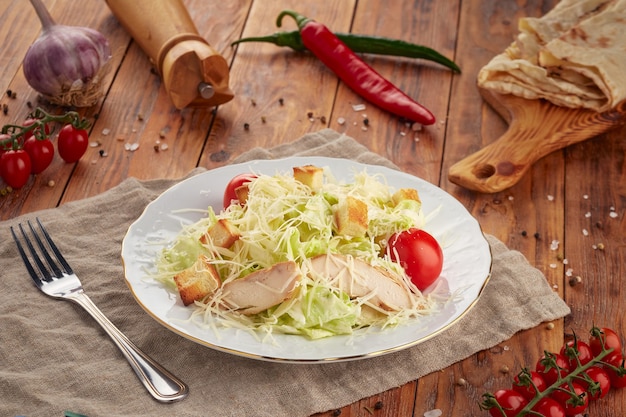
[23,0,111,107]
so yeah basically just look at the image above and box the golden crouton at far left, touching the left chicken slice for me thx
[174,255,222,306]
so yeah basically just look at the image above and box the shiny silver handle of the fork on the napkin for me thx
[70,291,189,403]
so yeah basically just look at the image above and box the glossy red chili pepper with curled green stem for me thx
[276,10,435,125]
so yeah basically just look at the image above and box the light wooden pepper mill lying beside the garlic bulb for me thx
[106,0,233,109]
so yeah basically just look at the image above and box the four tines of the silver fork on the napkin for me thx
[11,218,72,286]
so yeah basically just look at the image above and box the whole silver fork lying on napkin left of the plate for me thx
[11,218,189,403]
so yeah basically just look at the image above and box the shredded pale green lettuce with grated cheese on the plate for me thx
[154,168,432,339]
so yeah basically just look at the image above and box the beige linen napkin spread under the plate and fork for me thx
[0,130,569,417]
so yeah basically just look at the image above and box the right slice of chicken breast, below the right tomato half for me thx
[311,255,415,311]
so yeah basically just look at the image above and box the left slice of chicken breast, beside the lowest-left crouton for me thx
[222,261,302,315]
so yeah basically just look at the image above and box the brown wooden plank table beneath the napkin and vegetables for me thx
[0,0,626,417]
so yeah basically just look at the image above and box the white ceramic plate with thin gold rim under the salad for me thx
[122,157,491,363]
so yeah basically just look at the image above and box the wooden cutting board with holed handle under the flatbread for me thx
[448,89,626,193]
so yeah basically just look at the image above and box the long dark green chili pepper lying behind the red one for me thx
[231,30,461,73]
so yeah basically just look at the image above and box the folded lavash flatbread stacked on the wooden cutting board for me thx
[478,0,626,112]
